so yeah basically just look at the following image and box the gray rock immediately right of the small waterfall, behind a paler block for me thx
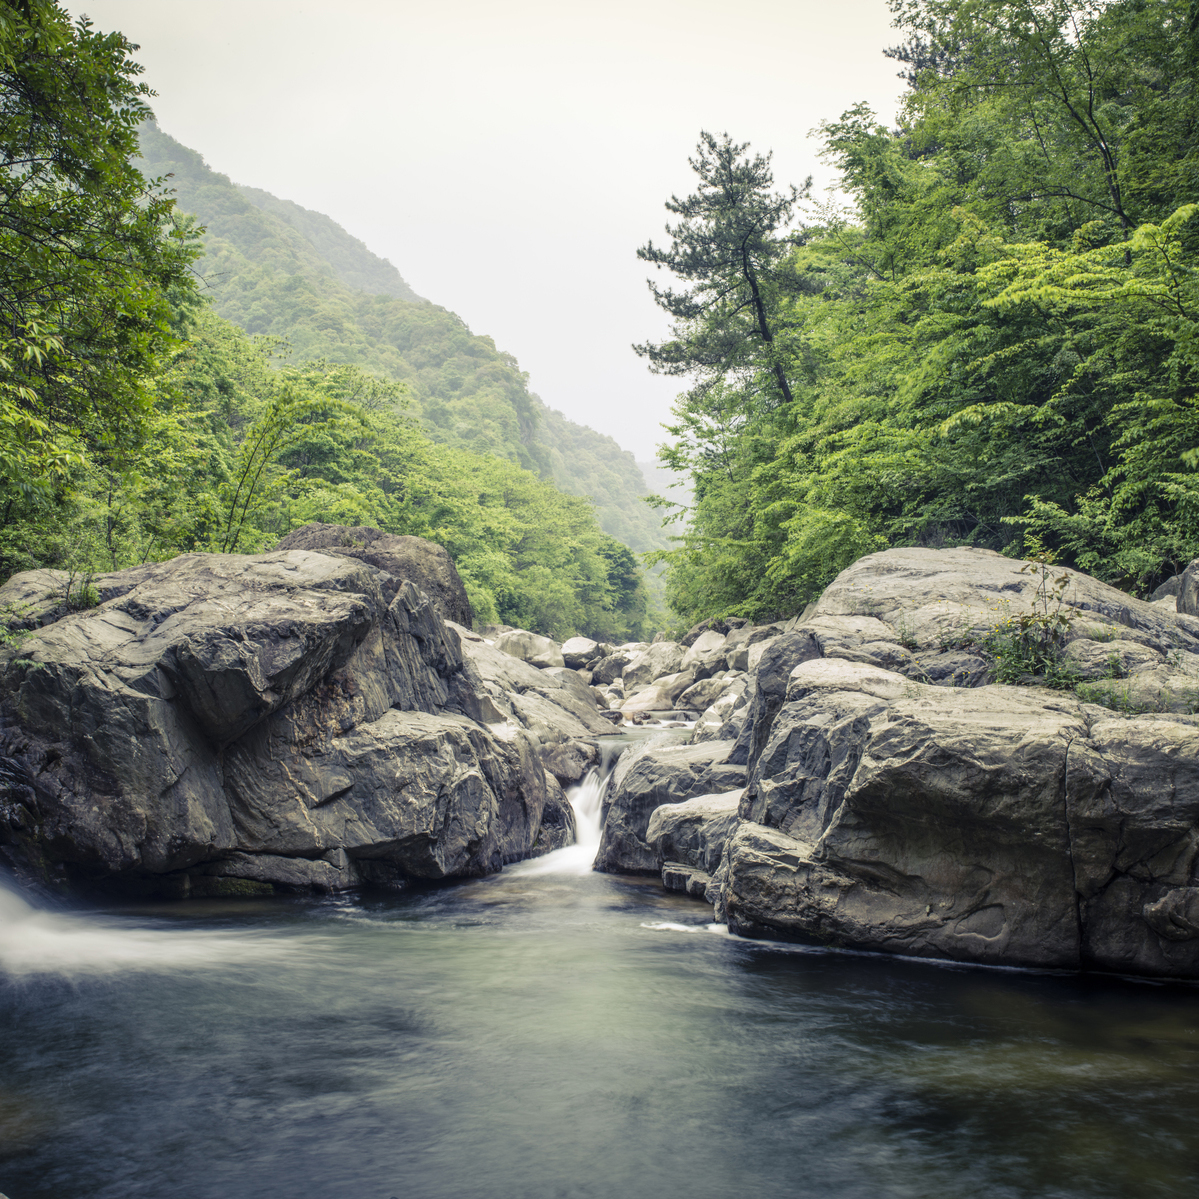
[595,739,733,874]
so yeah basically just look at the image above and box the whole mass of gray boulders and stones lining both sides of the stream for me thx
[0,525,1199,977]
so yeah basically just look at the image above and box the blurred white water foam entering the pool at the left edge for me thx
[0,885,297,978]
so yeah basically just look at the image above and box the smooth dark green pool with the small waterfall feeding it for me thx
[0,748,1199,1199]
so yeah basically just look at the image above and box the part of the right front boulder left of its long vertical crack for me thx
[725,661,1086,966]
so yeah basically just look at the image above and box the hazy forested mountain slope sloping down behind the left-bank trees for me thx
[140,122,667,550]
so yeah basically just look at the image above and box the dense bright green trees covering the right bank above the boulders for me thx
[651,0,1199,619]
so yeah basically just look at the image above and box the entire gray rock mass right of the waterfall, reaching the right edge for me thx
[598,549,1199,978]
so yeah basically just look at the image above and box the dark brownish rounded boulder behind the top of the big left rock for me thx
[275,523,472,628]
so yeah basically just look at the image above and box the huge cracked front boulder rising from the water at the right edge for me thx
[721,659,1199,977]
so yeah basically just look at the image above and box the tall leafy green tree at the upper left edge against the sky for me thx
[0,0,194,523]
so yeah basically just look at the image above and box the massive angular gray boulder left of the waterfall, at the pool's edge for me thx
[0,549,546,891]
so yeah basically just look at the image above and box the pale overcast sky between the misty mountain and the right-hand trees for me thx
[68,0,902,459]
